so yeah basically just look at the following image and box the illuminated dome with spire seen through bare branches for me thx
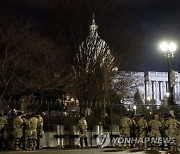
[77,14,114,72]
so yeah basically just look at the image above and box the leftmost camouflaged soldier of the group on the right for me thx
[120,114,132,148]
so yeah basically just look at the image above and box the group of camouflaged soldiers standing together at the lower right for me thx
[120,114,180,151]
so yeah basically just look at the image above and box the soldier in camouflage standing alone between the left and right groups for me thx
[78,114,88,147]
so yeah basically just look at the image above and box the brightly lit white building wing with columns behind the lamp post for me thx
[136,72,180,105]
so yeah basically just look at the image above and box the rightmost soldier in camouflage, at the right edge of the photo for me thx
[165,114,180,152]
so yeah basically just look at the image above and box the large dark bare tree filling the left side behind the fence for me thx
[0,20,68,98]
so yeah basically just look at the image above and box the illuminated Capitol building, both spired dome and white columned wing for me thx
[76,14,180,105]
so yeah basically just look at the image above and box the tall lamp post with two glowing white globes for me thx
[160,42,177,105]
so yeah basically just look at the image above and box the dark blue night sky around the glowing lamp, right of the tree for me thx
[121,0,180,72]
